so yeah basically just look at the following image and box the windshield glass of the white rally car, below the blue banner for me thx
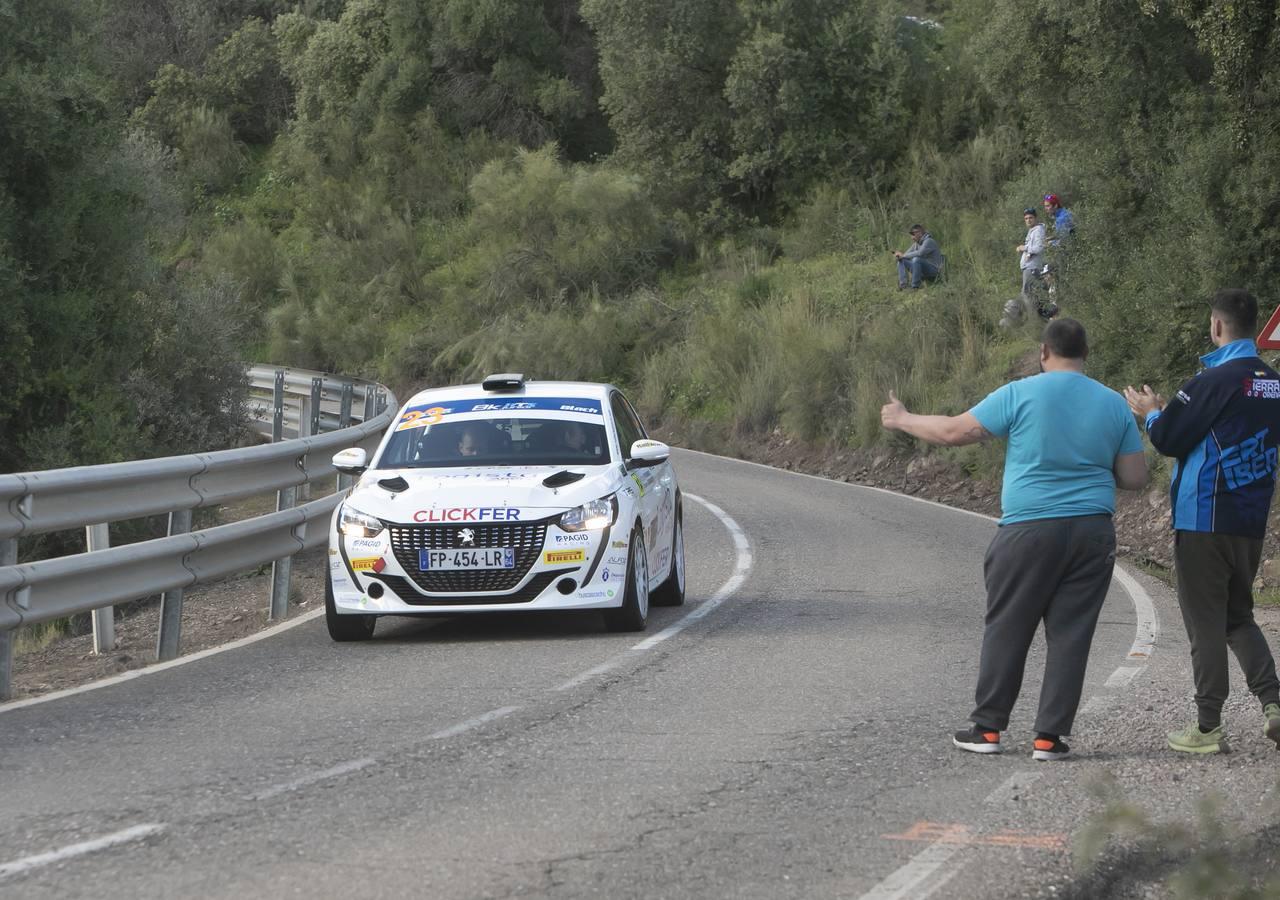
[378,416,609,469]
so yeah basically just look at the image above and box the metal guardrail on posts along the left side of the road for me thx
[0,366,397,700]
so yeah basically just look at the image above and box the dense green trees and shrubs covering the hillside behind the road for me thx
[0,0,1280,471]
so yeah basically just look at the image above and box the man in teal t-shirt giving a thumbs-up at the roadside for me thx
[881,319,1147,760]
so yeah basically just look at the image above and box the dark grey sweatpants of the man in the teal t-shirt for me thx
[969,516,1116,735]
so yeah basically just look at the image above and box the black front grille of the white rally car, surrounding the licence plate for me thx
[388,518,550,599]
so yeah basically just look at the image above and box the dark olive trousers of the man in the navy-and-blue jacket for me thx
[1174,531,1280,728]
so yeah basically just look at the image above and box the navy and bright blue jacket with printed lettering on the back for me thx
[1147,341,1280,538]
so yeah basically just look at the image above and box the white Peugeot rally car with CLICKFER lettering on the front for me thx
[325,375,685,641]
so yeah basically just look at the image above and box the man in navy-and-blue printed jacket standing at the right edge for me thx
[1125,288,1280,753]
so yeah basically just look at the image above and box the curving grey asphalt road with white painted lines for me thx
[0,452,1274,900]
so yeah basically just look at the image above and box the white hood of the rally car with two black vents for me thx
[347,466,621,522]
